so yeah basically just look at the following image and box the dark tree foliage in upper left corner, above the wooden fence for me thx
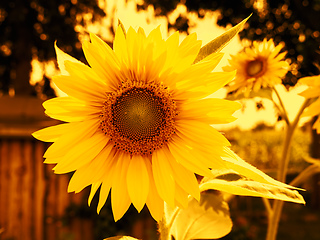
[0,0,105,95]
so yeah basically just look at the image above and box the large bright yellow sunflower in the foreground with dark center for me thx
[33,27,240,220]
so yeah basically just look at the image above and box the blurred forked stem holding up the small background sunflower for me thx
[266,98,310,240]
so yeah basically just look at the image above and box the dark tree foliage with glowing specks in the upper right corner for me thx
[138,0,320,85]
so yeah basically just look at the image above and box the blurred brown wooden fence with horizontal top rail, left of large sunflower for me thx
[0,97,93,240]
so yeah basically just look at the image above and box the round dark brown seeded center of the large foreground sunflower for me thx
[100,85,177,155]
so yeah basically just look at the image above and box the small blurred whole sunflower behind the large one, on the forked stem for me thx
[223,39,289,96]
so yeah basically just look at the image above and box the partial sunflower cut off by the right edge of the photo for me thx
[299,75,320,134]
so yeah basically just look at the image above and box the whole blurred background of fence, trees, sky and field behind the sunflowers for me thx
[0,0,320,240]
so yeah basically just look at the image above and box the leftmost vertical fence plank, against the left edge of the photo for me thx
[0,140,10,239]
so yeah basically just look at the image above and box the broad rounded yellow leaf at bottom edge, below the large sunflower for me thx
[170,191,232,240]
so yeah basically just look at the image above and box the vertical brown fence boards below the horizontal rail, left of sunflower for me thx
[0,139,93,240]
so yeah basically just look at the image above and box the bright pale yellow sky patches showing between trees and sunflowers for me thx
[31,0,312,130]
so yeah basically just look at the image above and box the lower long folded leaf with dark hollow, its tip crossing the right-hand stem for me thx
[199,170,305,204]
